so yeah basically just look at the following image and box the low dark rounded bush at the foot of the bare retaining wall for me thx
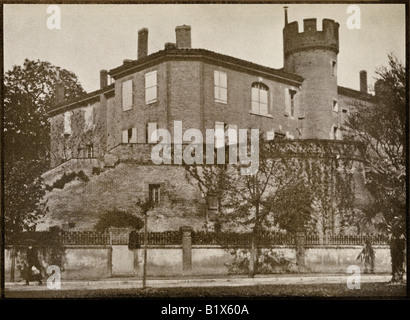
[94,209,144,232]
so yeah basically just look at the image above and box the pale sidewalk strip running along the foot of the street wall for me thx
[5,274,391,291]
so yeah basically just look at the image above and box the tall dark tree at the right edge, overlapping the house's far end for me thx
[346,54,407,282]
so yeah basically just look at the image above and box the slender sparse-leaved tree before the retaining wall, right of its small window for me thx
[223,139,303,277]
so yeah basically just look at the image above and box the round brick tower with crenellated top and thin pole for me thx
[283,15,339,139]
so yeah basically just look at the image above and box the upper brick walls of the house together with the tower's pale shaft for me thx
[51,54,372,167]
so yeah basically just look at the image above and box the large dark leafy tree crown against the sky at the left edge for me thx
[4,59,85,164]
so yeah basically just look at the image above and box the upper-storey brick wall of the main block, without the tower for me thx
[107,60,303,149]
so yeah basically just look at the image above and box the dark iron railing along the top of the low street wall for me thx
[6,231,389,247]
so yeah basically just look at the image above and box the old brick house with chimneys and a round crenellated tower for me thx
[45,13,370,231]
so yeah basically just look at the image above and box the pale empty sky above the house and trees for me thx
[3,4,405,92]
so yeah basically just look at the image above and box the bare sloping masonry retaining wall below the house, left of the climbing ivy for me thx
[37,160,206,231]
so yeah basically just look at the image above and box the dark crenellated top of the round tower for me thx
[283,18,339,57]
